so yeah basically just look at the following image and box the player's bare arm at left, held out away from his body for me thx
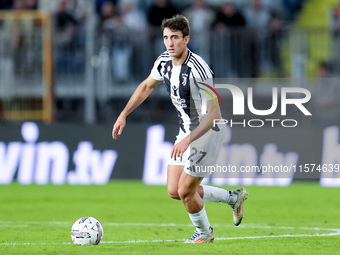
[112,76,162,139]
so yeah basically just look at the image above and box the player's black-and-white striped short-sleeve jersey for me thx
[150,50,213,134]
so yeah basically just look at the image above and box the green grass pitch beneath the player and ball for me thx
[0,181,340,255]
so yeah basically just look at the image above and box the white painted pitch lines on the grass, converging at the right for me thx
[0,221,340,246]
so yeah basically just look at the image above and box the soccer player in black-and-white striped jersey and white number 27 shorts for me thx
[112,15,248,243]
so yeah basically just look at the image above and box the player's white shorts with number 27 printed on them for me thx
[168,125,227,177]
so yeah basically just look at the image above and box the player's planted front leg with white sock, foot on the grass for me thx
[178,171,214,243]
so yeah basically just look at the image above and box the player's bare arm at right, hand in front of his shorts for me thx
[171,100,221,161]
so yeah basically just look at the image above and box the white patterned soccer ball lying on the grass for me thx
[71,217,104,245]
